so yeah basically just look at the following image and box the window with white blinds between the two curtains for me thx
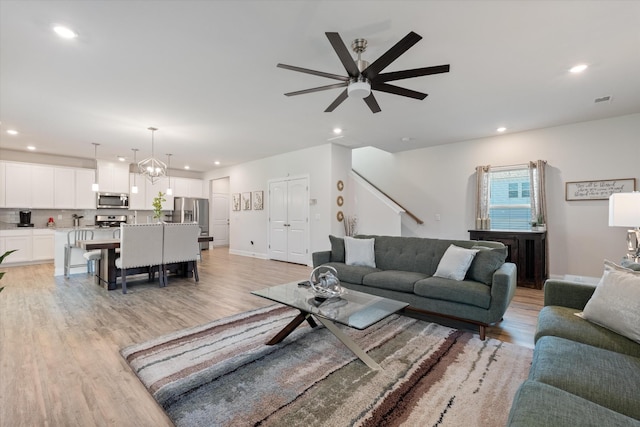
[489,166,531,230]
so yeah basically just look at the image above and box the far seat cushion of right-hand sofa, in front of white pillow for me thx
[535,305,640,357]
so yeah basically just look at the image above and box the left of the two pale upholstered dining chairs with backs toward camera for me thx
[116,224,164,294]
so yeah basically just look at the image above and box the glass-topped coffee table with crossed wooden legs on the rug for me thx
[251,282,409,370]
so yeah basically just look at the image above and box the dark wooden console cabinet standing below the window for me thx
[469,230,548,289]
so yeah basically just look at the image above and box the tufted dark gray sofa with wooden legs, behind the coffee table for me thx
[312,236,516,340]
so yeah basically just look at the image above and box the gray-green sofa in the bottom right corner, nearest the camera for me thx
[507,280,640,427]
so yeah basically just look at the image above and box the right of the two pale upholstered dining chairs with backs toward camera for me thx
[162,223,200,285]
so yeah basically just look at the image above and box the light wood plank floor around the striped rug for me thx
[0,248,542,427]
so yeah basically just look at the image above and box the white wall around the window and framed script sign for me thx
[352,114,640,277]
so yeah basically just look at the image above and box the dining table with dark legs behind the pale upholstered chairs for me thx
[76,236,213,291]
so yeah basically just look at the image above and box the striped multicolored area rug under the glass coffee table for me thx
[121,305,532,427]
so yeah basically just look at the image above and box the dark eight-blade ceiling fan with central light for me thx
[278,31,449,113]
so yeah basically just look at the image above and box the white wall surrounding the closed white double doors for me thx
[204,144,351,262]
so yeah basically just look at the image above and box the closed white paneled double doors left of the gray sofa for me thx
[269,178,309,264]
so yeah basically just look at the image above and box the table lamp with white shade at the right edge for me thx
[609,191,640,262]
